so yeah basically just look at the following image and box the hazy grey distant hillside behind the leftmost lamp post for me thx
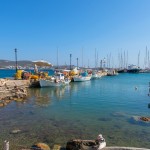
[0,60,34,68]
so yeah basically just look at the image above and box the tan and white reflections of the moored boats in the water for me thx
[28,81,91,107]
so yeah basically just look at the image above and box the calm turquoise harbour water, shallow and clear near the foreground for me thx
[0,73,150,149]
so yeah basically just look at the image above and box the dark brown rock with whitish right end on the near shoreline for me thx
[66,134,106,150]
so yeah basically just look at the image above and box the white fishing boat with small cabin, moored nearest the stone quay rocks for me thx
[39,72,71,87]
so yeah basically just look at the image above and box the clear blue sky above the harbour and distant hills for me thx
[0,0,150,67]
